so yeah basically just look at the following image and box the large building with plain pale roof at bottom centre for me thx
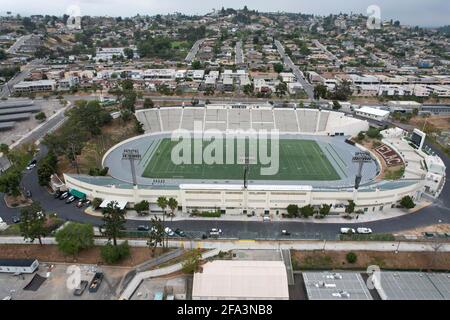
[192,260,289,300]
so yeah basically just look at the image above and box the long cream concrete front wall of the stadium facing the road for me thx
[64,175,422,214]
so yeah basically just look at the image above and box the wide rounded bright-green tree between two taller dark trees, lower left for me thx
[55,222,94,258]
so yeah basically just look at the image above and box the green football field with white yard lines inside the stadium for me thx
[143,139,340,181]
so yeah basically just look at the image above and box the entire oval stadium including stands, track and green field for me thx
[65,104,445,215]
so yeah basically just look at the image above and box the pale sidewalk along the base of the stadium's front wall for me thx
[85,201,431,224]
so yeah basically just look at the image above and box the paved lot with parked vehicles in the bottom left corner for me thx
[0,263,129,300]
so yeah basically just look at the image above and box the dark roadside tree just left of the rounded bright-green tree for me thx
[19,202,47,245]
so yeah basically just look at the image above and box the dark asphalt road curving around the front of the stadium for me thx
[0,140,450,240]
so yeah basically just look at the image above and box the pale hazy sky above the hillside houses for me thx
[0,0,450,26]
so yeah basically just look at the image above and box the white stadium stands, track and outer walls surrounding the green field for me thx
[64,104,445,215]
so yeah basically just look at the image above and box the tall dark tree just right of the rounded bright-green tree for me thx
[102,201,126,246]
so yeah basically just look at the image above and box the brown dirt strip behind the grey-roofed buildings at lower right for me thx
[292,251,450,270]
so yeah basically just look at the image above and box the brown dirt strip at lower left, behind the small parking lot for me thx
[0,244,167,267]
